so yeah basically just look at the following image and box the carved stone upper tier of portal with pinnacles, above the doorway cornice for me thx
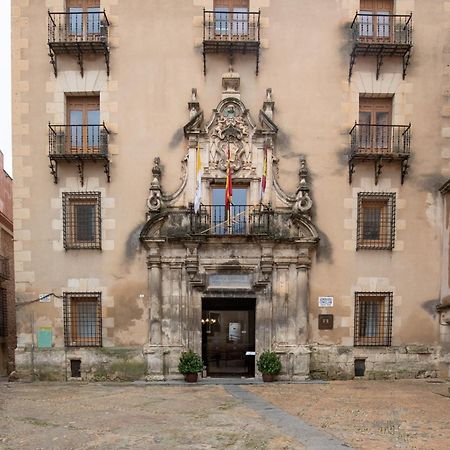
[141,69,319,251]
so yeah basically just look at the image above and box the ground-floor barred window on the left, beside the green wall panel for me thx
[63,292,103,347]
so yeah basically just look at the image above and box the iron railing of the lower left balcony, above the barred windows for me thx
[48,123,109,157]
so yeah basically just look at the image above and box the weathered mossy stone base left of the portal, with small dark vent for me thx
[16,347,147,381]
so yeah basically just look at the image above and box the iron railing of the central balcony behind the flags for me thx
[191,205,273,235]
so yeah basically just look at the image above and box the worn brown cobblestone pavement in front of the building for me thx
[0,380,450,450]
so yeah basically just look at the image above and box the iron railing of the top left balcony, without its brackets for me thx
[48,9,109,44]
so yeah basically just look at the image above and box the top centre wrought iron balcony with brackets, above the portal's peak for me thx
[203,10,260,75]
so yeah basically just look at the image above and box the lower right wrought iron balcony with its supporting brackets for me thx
[349,123,411,184]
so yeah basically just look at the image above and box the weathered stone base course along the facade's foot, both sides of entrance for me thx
[12,345,448,381]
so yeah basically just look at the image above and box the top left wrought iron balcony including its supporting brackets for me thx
[48,11,109,77]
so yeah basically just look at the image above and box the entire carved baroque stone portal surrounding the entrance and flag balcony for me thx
[140,69,319,379]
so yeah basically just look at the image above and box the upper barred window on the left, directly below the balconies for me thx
[62,192,102,250]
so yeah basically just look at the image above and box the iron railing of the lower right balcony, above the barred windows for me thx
[350,123,411,156]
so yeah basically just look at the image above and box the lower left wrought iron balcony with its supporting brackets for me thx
[48,123,110,185]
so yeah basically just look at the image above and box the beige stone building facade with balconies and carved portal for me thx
[12,0,450,380]
